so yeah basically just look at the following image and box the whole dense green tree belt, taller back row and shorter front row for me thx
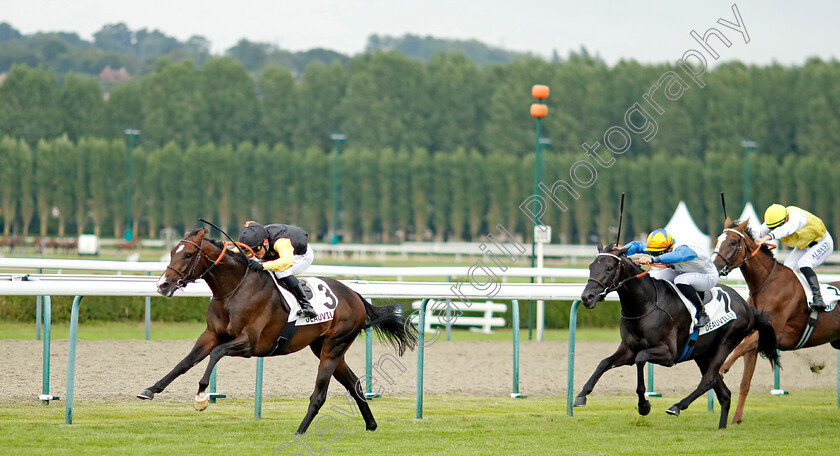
[0,51,840,242]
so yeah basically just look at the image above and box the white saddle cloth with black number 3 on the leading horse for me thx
[266,274,338,356]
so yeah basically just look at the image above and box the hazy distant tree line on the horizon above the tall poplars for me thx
[0,22,527,77]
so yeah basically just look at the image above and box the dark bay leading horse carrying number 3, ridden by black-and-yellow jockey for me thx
[137,228,417,434]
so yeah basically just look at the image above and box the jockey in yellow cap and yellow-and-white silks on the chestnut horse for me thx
[752,204,834,311]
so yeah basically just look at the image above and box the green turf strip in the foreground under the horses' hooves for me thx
[0,392,840,456]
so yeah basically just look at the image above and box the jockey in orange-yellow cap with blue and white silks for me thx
[624,228,720,327]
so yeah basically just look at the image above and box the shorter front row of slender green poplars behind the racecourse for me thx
[0,136,840,243]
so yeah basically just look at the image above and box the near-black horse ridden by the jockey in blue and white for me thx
[570,244,778,428]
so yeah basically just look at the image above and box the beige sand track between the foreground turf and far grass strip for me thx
[0,334,837,403]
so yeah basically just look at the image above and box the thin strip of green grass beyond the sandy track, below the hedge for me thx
[0,320,619,342]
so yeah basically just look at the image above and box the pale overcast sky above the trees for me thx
[0,0,840,65]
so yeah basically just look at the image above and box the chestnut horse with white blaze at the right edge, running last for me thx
[714,218,840,423]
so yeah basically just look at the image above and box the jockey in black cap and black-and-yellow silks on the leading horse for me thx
[239,221,316,318]
